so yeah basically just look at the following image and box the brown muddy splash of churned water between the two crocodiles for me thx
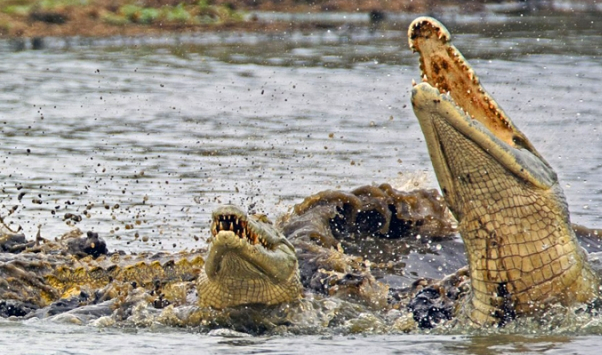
[279,184,464,310]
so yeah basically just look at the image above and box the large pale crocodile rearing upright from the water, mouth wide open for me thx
[408,17,599,325]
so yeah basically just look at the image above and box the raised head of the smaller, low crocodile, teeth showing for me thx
[198,206,302,309]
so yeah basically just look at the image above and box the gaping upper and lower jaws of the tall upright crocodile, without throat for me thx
[408,17,557,200]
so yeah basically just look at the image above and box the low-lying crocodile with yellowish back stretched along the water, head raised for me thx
[0,206,302,316]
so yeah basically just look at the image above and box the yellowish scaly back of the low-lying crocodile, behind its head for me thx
[0,233,204,308]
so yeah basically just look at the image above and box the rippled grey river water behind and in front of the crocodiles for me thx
[0,12,602,354]
